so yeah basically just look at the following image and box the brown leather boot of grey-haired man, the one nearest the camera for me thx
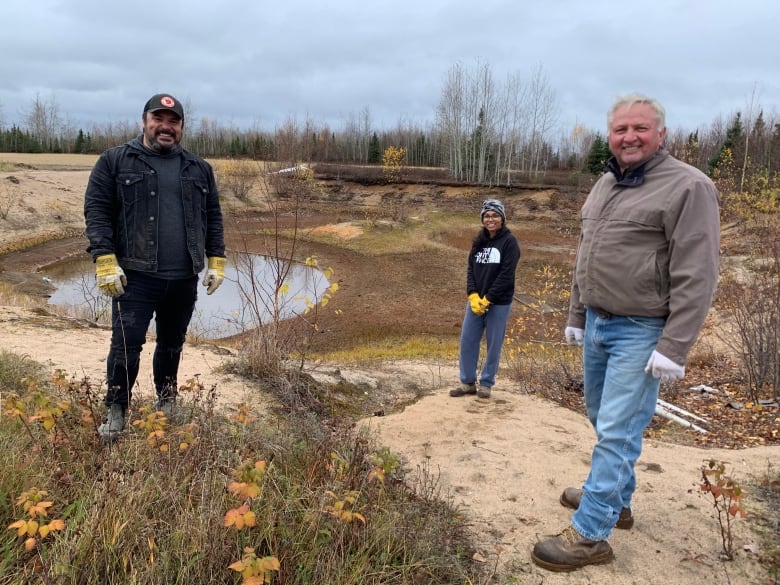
[531,526,615,572]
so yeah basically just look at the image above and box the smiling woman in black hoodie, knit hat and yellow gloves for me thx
[450,199,520,398]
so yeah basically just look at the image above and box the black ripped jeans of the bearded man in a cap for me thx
[105,270,198,408]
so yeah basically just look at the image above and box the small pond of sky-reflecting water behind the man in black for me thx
[43,254,330,339]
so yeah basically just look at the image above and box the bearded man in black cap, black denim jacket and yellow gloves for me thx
[84,94,225,441]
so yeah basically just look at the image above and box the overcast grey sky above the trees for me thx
[0,0,780,133]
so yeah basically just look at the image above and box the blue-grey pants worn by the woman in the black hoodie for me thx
[459,303,512,388]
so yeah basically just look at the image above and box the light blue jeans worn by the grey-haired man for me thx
[572,308,666,540]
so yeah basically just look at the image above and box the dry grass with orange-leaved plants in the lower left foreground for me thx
[0,353,481,585]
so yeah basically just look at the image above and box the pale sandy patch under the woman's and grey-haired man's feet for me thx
[366,388,780,585]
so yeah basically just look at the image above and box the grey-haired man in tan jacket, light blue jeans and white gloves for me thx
[531,94,720,571]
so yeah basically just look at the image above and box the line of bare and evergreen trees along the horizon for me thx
[0,62,780,190]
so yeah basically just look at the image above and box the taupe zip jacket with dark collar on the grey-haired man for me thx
[568,149,720,365]
